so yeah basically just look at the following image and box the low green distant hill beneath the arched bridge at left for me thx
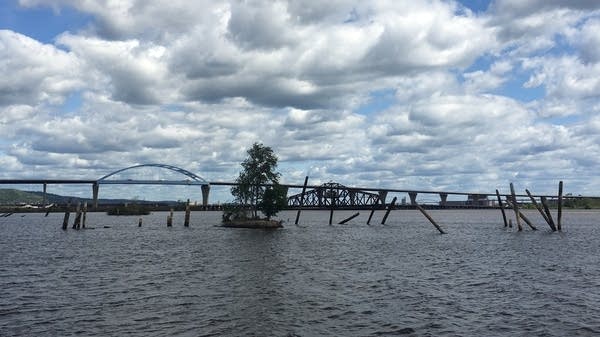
[0,188,177,206]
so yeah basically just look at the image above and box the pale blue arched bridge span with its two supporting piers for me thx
[92,164,210,207]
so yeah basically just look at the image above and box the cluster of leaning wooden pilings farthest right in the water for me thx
[496,181,563,232]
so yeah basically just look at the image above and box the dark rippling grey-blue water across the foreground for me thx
[0,210,600,336]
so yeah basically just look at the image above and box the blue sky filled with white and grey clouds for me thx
[0,0,600,202]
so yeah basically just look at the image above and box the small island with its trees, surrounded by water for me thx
[222,143,287,229]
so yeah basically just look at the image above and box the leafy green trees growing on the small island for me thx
[231,143,287,219]
